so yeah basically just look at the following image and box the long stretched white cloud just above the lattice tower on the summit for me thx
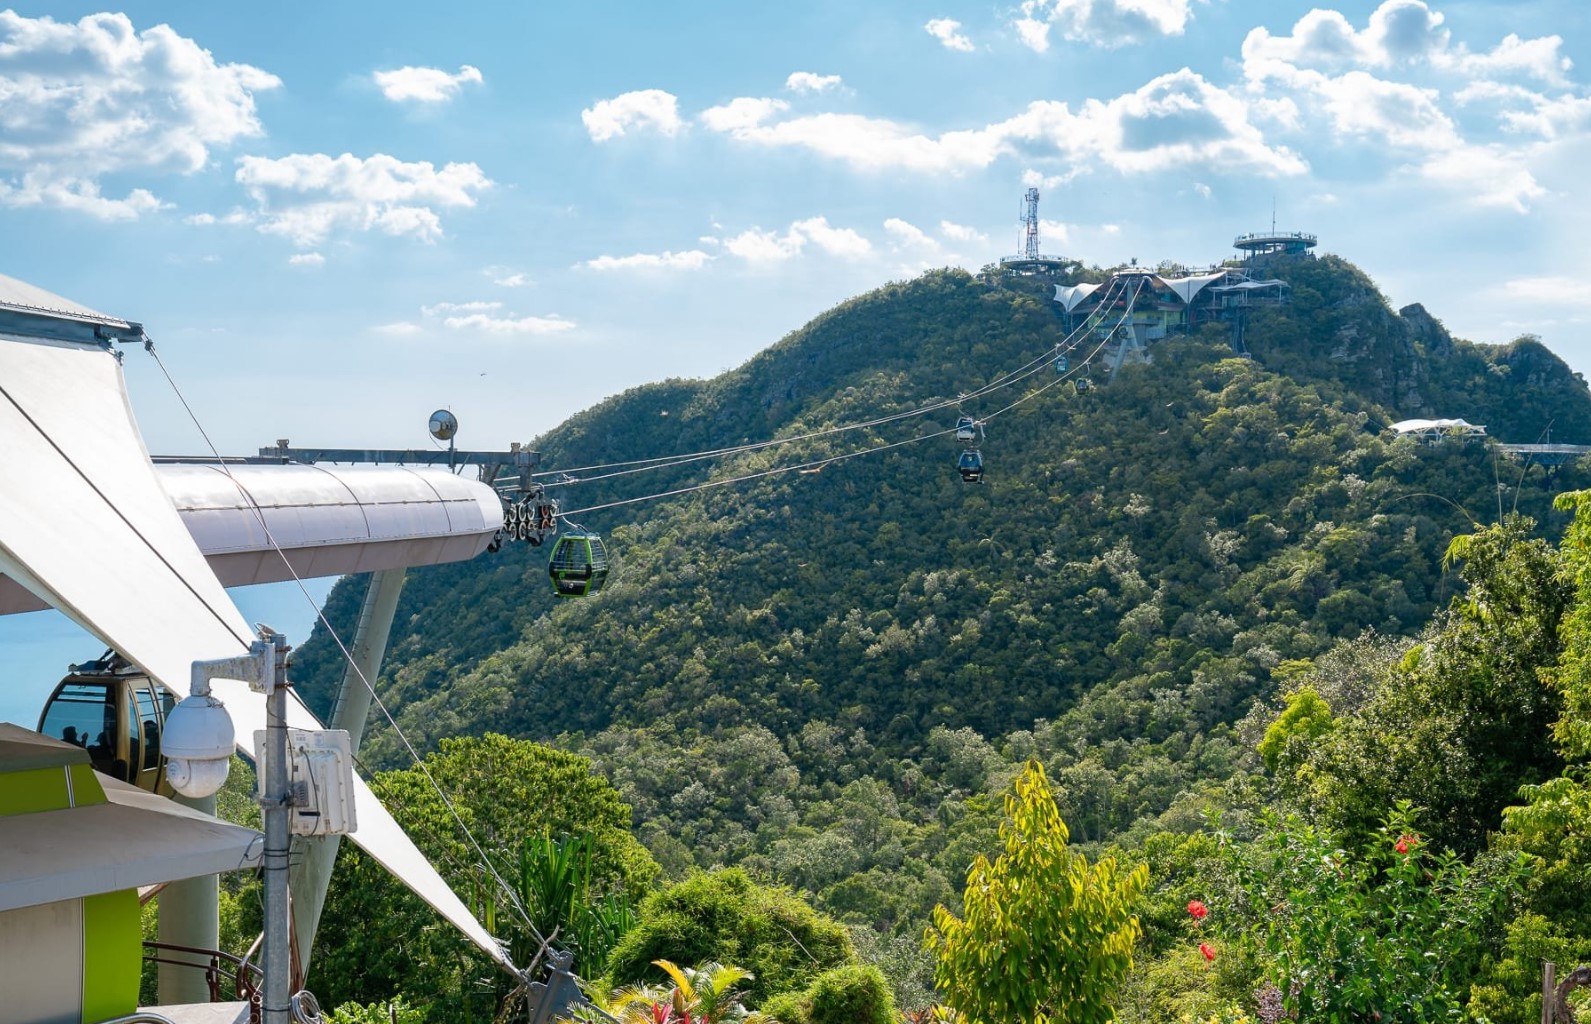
[710,68,1305,173]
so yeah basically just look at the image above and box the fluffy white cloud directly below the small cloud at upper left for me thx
[237,153,492,248]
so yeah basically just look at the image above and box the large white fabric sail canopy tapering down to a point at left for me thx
[0,336,512,970]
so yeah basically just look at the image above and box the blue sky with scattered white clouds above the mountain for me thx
[0,0,1591,718]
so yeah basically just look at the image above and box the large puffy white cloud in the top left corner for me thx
[0,10,282,219]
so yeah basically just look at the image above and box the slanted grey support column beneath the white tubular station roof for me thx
[288,569,404,976]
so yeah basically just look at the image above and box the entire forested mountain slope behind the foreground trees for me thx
[294,258,1591,1019]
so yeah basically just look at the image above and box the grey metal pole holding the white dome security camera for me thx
[259,633,293,1024]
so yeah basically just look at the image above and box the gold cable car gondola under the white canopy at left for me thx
[38,650,177,795]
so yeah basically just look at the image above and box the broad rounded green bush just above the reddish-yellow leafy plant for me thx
[608,868,854,1005]
